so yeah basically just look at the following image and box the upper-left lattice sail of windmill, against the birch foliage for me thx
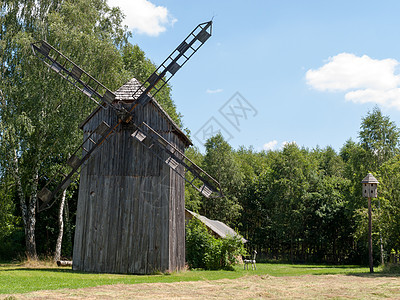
[31,41,116,107]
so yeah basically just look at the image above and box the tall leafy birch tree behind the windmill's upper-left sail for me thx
[0,0,128,259]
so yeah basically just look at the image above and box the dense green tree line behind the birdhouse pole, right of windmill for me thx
[186,107,400,263]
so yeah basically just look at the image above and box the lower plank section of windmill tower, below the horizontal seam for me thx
[73,176,185,274]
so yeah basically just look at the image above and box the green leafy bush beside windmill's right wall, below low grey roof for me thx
[186,218,246,270]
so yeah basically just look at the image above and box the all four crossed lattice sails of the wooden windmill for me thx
[31,21,222,211]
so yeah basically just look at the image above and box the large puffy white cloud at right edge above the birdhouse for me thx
[306,53,400,110]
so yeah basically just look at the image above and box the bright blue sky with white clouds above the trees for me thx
[109,0,400,151]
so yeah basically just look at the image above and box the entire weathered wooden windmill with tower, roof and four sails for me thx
[32,21,221,274]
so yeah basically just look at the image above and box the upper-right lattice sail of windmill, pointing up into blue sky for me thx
[132,21,212,105]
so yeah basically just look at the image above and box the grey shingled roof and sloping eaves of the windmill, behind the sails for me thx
[80,78,193,146]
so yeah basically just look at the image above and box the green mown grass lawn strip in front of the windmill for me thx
[0,263,379,294]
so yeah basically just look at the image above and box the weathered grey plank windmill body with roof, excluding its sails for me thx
[73,79,191,274]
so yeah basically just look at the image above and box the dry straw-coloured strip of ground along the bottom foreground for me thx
[4,275,400,300]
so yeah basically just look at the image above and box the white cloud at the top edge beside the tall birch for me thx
[108,0,177,36]
